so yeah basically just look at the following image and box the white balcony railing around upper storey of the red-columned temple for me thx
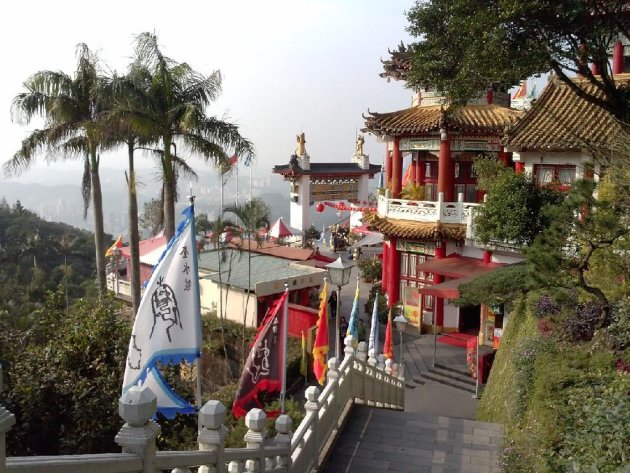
[378,192,479,224]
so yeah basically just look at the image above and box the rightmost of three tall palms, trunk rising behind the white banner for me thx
[120,33,254,239]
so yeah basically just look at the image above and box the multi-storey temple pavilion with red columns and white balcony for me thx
[364,46,523,345]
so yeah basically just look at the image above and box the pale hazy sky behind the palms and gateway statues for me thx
[0,0,414,180]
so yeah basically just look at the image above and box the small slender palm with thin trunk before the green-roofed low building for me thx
[225,198,271,363]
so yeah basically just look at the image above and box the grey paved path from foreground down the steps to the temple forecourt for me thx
[323,249,503,473]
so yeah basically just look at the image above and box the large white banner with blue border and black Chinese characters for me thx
[123,206,201,418]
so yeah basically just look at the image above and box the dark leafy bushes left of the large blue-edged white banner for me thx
[0,291,131,455]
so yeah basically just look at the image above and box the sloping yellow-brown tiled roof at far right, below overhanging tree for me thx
[503,74,630,150]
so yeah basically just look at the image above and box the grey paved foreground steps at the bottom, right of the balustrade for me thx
[322,406,503,473]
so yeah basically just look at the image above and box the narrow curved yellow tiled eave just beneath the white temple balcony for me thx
[363,213,466,241]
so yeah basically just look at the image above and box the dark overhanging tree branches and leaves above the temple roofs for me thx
[407,0,630,119]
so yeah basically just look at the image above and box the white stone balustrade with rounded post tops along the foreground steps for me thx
[0,337,404,473]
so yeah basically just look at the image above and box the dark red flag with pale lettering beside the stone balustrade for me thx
[232,292,287,419]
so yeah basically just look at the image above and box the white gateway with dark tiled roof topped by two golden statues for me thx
[272,133,381,231]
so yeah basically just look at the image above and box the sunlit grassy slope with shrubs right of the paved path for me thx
[478,292,630,473]
